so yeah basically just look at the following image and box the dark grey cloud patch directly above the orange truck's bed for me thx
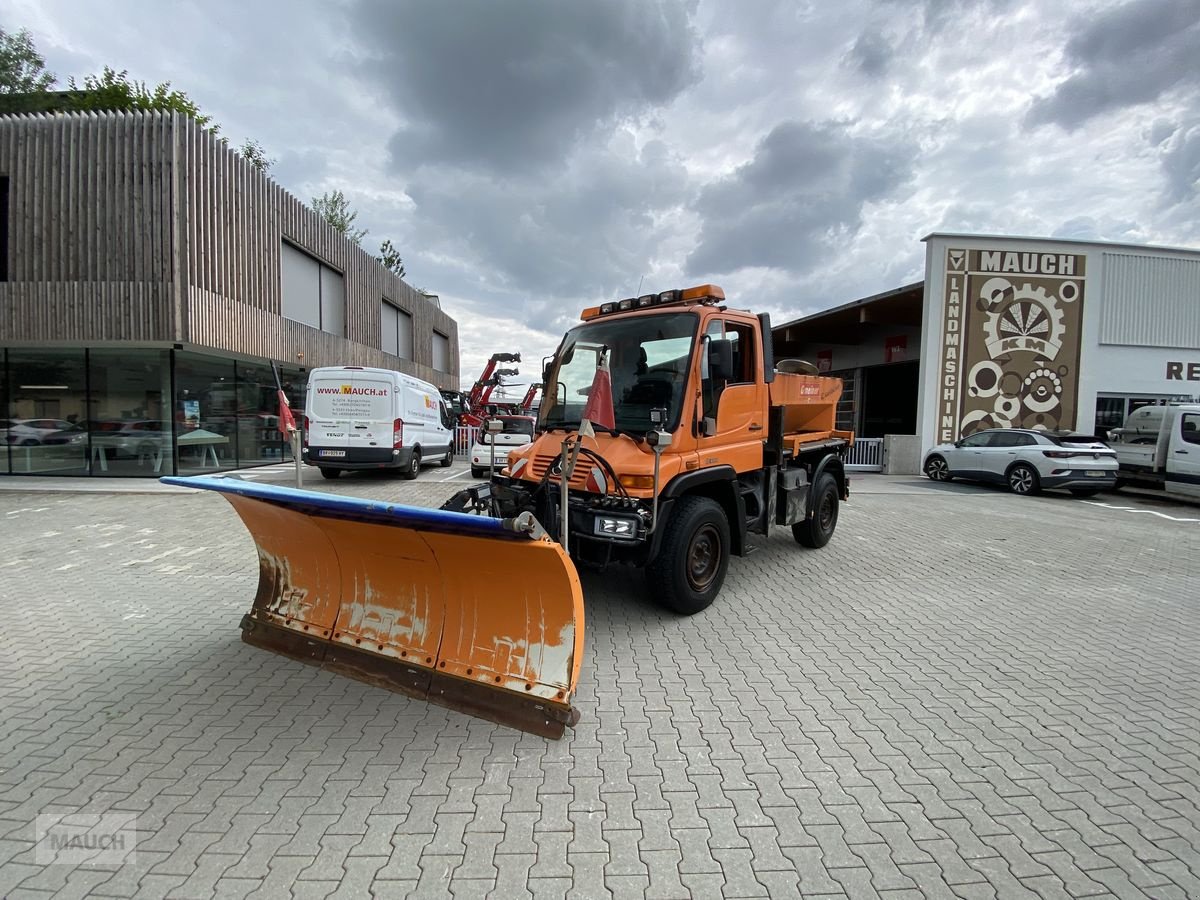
[688,121,913,275]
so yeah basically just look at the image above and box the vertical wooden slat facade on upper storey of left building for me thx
[0,113,458,388]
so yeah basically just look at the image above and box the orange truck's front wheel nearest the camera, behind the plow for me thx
[646,497,731,616]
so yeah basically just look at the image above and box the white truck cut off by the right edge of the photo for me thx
[1109,404,1200,499]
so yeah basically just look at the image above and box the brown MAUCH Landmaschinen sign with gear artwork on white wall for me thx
[937,248,1087,442]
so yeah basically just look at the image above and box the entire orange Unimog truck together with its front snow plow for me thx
[164,284,853,737]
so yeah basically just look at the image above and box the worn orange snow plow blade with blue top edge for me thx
[162,476,583,738]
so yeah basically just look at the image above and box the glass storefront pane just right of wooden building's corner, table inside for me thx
[172,352,238,475]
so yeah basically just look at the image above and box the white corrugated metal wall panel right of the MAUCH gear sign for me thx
[1100,253,1200,348]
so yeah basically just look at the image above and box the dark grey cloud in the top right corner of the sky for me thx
[1025,0,1200,130]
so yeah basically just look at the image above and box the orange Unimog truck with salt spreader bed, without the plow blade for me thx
[443,284,853,614]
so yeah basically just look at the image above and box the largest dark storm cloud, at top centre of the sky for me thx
[352,0,698,173]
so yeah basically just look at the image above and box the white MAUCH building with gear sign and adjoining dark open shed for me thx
[774,234,1200,472]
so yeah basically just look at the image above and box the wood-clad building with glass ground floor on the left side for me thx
[0,113,458,476]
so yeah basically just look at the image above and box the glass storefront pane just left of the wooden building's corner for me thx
[86,349,170,478]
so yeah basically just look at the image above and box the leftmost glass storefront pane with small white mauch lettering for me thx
[2,349,88,475]
